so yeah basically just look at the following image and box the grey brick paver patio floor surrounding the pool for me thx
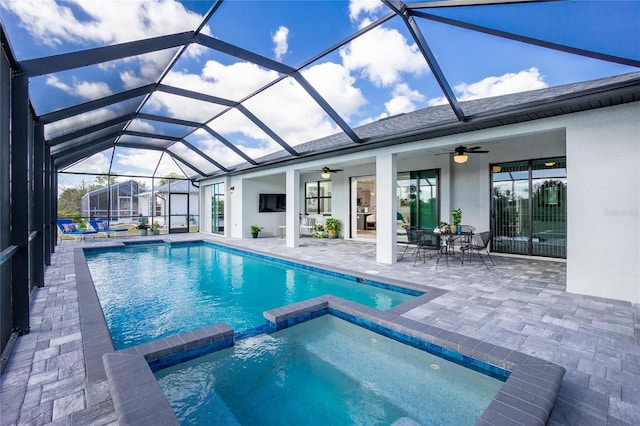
[0,234,640,425]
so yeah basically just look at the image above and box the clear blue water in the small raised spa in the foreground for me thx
[155,315,503,425]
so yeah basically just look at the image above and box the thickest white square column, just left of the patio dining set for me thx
[376,153,398,265]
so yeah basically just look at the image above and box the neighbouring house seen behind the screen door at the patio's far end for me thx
[139,180,200,232]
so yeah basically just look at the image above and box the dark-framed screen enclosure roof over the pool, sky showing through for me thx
[0,0,640,180]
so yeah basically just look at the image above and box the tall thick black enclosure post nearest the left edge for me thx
[11,74,31,334]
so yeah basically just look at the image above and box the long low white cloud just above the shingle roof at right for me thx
[428,68,548,106]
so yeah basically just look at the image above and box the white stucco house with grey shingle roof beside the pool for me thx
[200,73,640,303]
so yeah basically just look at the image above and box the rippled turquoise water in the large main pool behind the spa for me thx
[85,243,414,349]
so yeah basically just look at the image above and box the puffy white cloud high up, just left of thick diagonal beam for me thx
[340,27,428,87]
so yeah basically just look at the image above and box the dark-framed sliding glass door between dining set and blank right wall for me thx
[491,157,567,258]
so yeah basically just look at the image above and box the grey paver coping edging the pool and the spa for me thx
[74,240,565,425]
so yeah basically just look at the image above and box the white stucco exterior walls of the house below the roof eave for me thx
[200,102,640,303]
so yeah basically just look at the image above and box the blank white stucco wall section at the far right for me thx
[567,103,640,303]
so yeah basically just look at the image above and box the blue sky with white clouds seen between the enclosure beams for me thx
[0,0,640,188]
